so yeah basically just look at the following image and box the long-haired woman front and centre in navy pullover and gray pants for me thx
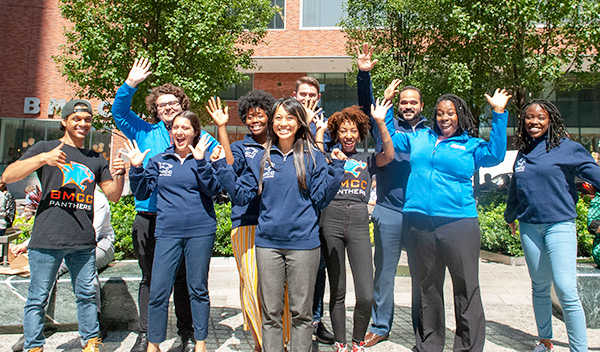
[211,98,345,352]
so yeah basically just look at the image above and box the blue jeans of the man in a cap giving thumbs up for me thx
[23,248,98,351]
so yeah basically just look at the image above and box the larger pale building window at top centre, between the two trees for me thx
[302,0,343,28]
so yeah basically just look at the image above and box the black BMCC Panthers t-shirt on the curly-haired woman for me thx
[333,153,377,204]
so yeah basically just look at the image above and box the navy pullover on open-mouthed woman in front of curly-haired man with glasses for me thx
[129,147,219,238]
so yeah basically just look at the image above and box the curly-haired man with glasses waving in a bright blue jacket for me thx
[112,58,218,352]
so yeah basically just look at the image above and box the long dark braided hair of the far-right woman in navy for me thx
[514,99,569,153]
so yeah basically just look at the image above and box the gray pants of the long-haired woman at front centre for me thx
[256,247,321,352]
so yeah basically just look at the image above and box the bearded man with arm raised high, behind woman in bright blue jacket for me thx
[357,44,427,347]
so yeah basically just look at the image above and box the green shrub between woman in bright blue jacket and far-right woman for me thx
[477,204,523,257]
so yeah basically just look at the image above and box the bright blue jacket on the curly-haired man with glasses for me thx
[111,83,219,213]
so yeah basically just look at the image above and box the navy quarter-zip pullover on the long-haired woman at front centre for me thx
[213,146,344,250]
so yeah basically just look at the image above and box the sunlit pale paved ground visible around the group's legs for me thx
[0,253,600,352]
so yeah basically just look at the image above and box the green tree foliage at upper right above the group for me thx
[341,0,600,115]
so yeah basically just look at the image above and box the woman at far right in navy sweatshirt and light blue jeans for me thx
[504,99,600,352]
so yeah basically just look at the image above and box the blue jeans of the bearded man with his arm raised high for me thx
[369,205,420,336]
